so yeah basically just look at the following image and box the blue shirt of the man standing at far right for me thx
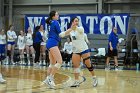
[108,31,118,49]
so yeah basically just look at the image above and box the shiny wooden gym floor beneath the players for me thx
[0,65,140,93]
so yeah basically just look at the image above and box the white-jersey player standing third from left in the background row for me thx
[17,30,25,64]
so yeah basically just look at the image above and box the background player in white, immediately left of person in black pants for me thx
[26,27,35,65]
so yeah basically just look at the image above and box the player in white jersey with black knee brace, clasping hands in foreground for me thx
[60,17,98,87]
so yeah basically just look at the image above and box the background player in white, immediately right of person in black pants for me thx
[39,25,47,65]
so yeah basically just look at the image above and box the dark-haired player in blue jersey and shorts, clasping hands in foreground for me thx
[43,11,72,88]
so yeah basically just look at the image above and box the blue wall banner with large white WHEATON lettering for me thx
[25,14,129,35]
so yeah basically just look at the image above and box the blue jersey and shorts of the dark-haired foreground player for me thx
[46,20,61,49]
